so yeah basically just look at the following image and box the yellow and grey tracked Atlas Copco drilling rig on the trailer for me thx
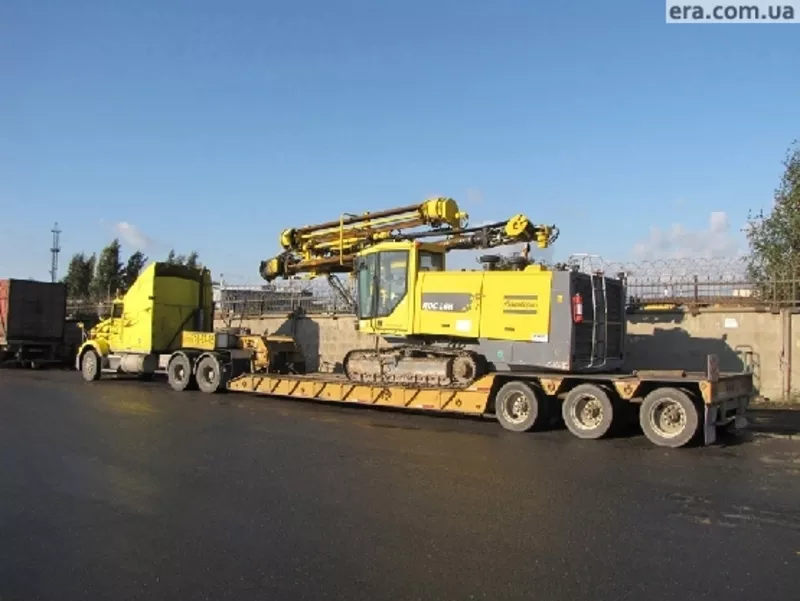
[260,198,625,387]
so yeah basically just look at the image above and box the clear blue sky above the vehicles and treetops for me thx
[0,0,800,283]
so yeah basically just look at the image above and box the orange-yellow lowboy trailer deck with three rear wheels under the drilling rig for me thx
[226,355,753,447]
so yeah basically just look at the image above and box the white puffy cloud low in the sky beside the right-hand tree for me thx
[633,211,742,260]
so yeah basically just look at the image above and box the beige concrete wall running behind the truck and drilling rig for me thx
[216,310,800,402]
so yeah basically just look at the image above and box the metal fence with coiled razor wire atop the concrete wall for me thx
[64,255,800,321]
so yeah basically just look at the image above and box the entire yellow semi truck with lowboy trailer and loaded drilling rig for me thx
[76,199,753,447]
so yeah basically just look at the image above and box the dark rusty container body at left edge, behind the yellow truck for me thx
[0,279,67,346]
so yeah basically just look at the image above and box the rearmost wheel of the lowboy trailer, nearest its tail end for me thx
[639,388,700,449]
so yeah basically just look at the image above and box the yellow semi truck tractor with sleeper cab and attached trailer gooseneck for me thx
[75,263,305,393]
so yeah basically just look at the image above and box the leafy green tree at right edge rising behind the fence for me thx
[747,141,800,303]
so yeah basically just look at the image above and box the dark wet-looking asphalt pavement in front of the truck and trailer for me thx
[0,370,800,601]
